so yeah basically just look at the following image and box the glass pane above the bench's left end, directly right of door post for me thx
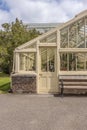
[60,53,67,71]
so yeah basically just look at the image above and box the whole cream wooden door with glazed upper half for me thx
[39,47,58,93]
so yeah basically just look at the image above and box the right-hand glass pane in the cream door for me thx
[48,48,55,72]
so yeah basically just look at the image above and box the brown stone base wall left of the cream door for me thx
[11,74,36,93]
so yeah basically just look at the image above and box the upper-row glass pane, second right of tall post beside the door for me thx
[69,23,76,48]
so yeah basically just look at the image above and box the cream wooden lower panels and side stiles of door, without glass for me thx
[39,48,58,93]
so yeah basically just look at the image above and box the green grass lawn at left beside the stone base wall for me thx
[0,72,10,93]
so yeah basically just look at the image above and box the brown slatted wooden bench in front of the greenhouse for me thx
[59,75,87,96]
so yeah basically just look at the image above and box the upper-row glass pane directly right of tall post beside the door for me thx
[60,28,68,48]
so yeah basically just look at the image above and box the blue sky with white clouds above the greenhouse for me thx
[0,0,87,26]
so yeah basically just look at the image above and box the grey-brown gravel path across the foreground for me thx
[0,94,87,130]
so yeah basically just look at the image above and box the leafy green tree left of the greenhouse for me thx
[0,18,40,74]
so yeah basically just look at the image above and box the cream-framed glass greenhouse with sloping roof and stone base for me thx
[12,11,87,93]
